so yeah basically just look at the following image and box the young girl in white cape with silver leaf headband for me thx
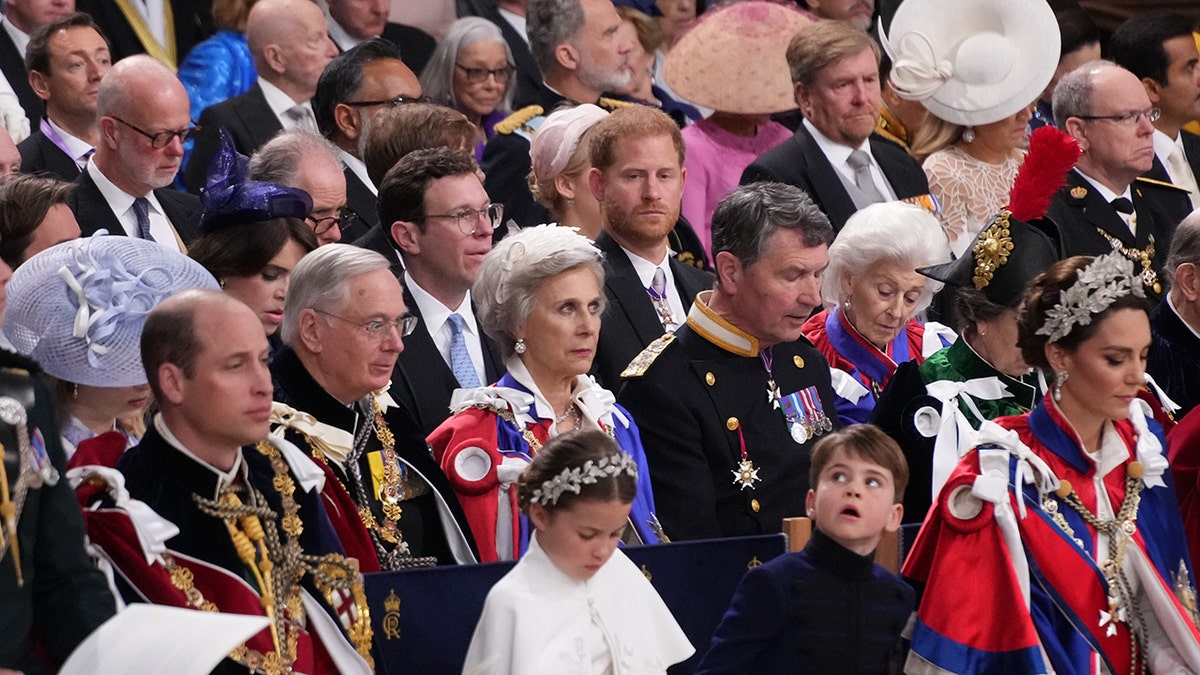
[463,430,695,675]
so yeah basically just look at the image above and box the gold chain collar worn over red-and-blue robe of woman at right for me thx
[1057,461,1150,673]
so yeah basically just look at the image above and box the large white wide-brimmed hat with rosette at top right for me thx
[880,0,1061,126]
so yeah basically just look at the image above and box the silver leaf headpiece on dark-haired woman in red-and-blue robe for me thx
[1036,251,1145,342]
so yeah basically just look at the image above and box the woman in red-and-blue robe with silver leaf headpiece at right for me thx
[904,253,1200,674]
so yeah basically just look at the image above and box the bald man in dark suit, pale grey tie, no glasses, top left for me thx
[184,0,337,193]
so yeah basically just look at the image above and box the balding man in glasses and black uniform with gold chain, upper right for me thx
[1048,61,1192,299]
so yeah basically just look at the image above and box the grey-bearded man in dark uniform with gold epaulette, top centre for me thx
[481,0,634,227]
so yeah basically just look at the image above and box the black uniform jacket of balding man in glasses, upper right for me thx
[1046,171,1192,299]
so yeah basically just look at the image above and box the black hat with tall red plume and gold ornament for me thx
[917,126,1080,307]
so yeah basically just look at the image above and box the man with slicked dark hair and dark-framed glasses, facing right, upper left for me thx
[312,38,421,241]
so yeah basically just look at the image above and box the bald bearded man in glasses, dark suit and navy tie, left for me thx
[70,54,202,252]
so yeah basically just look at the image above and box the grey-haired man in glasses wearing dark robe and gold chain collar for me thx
[271,244,476,572]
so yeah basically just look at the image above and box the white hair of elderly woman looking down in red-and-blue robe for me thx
[821,202,950,311]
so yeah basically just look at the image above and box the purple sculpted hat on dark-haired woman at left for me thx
[200,129,312,233]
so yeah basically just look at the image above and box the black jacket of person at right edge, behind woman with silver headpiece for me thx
[1146,299,1200,419]
